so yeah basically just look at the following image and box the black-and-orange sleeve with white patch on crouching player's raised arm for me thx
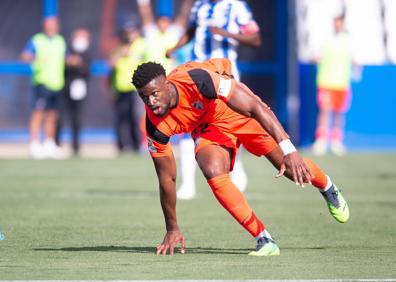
[188,68,236,102]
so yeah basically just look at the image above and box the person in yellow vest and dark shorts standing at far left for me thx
[21,16,66,159]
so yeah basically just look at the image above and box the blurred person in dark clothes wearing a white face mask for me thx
[56,28,92,156]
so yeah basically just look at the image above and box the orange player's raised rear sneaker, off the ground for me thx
[321,184,349,223]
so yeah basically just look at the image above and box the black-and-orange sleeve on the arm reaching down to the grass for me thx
[146,115,172,158]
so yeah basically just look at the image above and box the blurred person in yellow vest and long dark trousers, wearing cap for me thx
[110,20,146,153]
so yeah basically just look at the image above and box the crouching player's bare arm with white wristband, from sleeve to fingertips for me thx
[226,82,313,187]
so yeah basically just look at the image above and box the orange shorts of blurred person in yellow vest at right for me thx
[318,88,351,113]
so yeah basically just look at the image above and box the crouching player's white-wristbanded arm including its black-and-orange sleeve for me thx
[188,65,312,187]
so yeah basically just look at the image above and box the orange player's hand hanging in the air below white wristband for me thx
[276,152,314,187]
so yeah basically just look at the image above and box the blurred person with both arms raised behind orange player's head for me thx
[137,0,192,72]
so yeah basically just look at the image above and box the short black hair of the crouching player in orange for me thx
[132,62,166,89]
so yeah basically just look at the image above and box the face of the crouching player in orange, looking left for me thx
[138,76,171,116]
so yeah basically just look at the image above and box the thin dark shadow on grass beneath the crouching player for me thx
[33,246,326,255]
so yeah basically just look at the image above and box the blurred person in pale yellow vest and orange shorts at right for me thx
[312,15,353,155]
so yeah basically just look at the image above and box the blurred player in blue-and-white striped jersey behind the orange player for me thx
[167,0,261,200]
